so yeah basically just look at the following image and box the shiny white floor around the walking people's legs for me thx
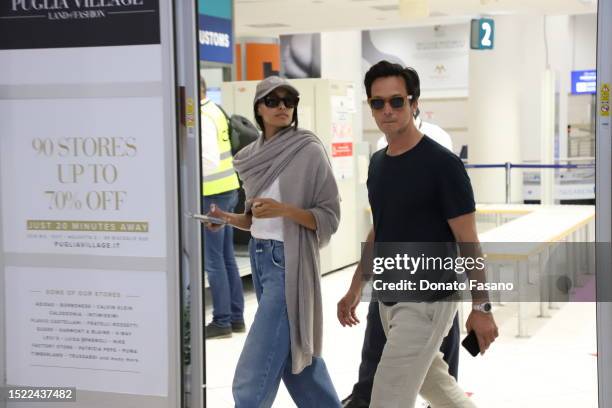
[206,267,597,408]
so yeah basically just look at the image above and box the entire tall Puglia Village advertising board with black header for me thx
[0,0,180,408]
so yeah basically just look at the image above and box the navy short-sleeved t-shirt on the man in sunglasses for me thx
[367,136,476,302]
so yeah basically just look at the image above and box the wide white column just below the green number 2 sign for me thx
[468,16,523,203]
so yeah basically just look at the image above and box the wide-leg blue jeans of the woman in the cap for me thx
[232,238,341,408]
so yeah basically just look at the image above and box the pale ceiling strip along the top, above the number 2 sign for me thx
[235,0,597,37]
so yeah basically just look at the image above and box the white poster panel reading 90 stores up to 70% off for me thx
[0,98,166,257]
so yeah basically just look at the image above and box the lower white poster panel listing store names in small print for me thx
[6,267,168,396]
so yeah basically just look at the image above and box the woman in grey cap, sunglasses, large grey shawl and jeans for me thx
[210,76,341,408]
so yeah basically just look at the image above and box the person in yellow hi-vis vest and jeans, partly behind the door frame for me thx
[200,78,245,339]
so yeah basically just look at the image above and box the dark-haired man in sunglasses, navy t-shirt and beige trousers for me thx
[338,61,498,408]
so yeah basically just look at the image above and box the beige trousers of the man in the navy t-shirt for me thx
[370,301,476,408]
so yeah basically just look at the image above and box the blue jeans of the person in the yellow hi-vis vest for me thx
[202,190,244,327]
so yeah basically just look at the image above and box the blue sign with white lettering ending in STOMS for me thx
[198,14,234,64]
